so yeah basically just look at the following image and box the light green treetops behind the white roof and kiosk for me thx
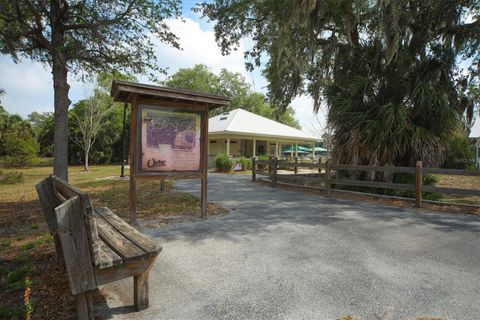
[163,64,300,128]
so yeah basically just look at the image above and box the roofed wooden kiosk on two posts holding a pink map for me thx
[111,80,230,224]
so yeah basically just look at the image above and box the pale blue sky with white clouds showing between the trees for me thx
[0,0,480,136]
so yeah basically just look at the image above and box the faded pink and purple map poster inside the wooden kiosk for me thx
[140,106,200,172]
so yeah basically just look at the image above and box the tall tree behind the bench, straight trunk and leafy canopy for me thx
[0,0,180,179]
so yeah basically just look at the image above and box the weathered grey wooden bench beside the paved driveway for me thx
[36,175,161,319]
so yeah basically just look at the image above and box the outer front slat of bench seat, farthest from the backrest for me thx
[95,207,162,254]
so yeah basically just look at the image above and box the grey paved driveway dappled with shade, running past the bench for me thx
[100,174,480,320]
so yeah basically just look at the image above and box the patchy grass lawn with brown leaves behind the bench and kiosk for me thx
[0,164,226,319]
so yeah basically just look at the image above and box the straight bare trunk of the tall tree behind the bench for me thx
[52,18,70,181]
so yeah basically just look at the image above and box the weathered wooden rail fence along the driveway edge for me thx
[252,157,480,208]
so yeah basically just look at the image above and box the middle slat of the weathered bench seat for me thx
[95,213,149,262]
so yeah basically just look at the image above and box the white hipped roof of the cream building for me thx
[208,109,320,141]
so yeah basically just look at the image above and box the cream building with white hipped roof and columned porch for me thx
[208,109,320,162]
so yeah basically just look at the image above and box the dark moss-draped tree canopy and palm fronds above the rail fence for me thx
[199,0,480,165]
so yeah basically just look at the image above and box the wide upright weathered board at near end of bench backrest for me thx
[55,196,97,294]
